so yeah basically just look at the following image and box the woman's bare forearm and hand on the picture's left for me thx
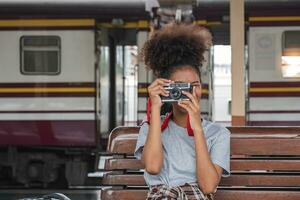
[141,79,170,175]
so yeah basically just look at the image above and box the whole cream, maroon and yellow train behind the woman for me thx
[0,0,300,188]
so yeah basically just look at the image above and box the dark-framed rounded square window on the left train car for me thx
[20,36,61,75]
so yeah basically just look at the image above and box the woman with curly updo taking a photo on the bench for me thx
[135,23,230,199]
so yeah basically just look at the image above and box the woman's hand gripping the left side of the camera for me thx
[148,78,171,109]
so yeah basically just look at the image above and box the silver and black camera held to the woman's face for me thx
[160,82,193,102]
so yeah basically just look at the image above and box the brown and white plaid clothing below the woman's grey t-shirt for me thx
[147,183,214,200]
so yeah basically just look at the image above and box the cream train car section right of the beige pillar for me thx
[247,15,300,126]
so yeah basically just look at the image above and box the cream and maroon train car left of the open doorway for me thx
[0,19,98,188]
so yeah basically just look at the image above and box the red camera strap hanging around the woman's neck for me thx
[147,99,194,136]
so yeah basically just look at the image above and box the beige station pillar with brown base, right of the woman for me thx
[230,0,246,126]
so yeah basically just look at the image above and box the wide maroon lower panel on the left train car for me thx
[0,120,96,146]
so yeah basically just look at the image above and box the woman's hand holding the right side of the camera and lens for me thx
[178,87,202,131]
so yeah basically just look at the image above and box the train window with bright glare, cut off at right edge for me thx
[281,30,300,78]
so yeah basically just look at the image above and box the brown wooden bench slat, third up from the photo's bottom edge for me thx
[104,158,300,171]
